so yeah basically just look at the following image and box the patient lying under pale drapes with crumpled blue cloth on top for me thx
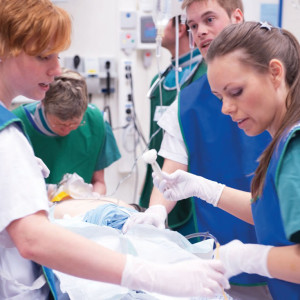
[49,174,232,300]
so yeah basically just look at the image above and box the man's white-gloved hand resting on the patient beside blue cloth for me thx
[122,204,168,233]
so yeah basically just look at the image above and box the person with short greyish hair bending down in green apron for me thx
[13,69,121,195]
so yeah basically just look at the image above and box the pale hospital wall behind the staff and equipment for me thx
[49,0,300,203]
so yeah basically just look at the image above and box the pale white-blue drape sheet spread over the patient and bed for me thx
[52,212,232,300]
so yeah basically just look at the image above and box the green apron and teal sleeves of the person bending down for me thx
[13,103,120,184]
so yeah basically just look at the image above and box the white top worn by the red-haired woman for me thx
[0,124,49,300]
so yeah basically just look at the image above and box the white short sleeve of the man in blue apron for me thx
[158,98,188,165]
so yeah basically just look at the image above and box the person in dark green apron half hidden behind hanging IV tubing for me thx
[140,16,206,235]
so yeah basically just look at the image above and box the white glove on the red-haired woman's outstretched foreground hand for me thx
[121,255,229,297]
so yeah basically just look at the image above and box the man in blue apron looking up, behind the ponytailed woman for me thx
[127,0,271,300]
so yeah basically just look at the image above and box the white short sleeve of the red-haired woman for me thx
[0,124,49,243]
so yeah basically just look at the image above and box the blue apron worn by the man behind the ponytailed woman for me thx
[179,75,271,285]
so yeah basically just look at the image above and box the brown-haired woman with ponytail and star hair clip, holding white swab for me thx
[155,22,300,300]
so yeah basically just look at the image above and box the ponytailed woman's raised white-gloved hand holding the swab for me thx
[152,170,225,206]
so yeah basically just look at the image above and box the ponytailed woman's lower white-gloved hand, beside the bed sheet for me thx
[214,240,272,278]
